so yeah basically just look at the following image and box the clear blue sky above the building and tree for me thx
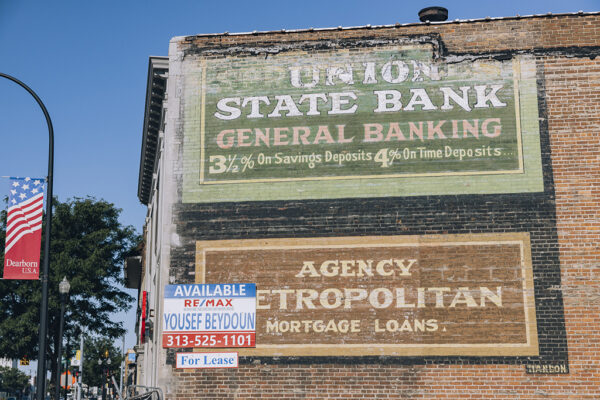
[0,0,600,366]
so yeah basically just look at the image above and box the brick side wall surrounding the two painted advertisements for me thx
[167,15,600,400]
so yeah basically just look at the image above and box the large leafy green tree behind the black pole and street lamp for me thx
[0,198,140,388]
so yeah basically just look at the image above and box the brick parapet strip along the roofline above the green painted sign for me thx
[179,14,600,53]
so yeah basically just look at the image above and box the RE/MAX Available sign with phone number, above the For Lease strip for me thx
[162,283,256,348]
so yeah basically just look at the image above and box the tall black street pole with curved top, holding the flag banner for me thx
[0,72,54,400]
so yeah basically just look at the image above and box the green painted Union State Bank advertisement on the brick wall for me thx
[182,44,543,202]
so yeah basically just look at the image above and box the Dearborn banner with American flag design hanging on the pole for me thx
[4,178,45,279]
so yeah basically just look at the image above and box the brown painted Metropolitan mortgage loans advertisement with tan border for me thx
[196,233,538,356]
